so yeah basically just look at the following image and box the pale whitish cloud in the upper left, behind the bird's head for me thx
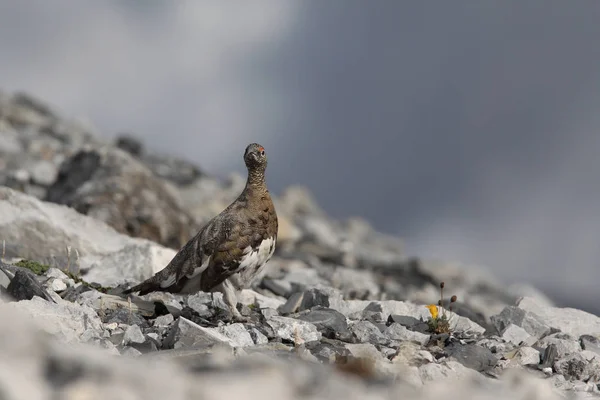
[0,0,295,170]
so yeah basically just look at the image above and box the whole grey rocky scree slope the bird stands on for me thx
[0,90,600,399]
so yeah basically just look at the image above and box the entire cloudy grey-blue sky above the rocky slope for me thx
[0,0,600,306]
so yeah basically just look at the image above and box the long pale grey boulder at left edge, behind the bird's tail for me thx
[0,187,175,285]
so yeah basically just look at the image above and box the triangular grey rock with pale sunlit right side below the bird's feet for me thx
[163,317,234,349]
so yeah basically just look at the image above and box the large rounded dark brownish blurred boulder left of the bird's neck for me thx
[45,146,198,249]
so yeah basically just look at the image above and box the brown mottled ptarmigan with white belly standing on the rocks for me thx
[123,143,278,321]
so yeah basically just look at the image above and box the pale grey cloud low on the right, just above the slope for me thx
[408,122,600,304]
